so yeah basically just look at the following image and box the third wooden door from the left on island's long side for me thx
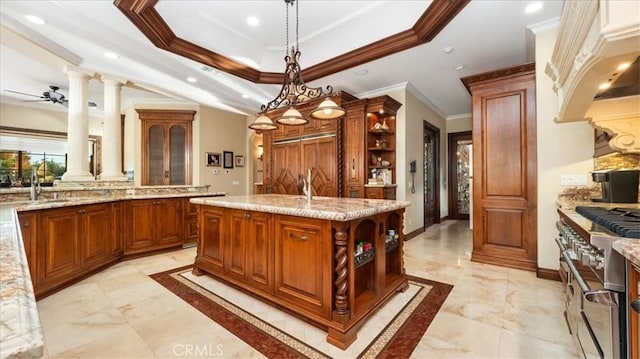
[245,212,273,292]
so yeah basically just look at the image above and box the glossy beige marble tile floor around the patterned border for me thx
[38,221,578,358]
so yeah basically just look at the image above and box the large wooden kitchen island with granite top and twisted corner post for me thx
[190,194,410,349]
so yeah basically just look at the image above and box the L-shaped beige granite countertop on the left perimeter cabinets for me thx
[0,190,225,358]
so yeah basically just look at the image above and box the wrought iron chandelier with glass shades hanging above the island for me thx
[249,0,345,131]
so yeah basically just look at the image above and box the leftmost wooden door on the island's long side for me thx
[197,206,226,273]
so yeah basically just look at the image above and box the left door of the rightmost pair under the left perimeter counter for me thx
[125,199,156,253]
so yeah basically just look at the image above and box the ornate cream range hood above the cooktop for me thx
[545,0,640,153]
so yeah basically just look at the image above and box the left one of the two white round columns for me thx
[62,66,95,182]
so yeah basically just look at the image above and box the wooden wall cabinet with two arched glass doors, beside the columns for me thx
[136,110,195,186]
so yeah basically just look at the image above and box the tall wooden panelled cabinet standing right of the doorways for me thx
[462,63,537,271]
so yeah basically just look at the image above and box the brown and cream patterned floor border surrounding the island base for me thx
[151,266,453,358]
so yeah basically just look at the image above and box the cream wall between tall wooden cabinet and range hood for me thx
[536,24,593,269]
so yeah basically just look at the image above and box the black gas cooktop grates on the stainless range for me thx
[576,206,640,239]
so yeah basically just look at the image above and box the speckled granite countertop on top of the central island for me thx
[191,194,411,221]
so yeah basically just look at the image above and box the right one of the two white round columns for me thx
[100,75,127,181]
